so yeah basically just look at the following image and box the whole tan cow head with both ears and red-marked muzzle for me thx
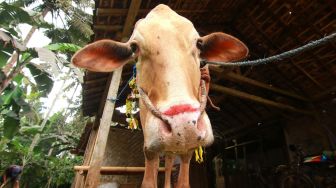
[72,5,248,153]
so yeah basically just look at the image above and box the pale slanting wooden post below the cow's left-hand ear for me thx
[85,67,122,188]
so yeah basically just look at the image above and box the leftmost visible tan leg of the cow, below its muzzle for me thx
[141,149,159,188]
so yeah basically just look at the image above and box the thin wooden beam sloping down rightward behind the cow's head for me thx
[210,84,312,115]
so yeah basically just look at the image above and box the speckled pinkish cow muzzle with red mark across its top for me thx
[148,104,213,153]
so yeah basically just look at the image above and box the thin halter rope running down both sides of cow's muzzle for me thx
[136,70,209,125]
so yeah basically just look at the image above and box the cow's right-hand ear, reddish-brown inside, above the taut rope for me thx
[197,32,249,62]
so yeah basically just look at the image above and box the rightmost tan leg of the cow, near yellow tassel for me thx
[176,152,193,188]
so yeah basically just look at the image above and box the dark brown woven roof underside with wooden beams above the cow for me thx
[82,0,336,140]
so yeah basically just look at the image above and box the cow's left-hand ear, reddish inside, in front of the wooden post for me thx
[71,40,134,72]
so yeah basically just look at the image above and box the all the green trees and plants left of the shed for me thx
[0,0,93,187]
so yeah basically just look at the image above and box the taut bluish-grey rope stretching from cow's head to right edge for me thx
[201,33,336,67]
